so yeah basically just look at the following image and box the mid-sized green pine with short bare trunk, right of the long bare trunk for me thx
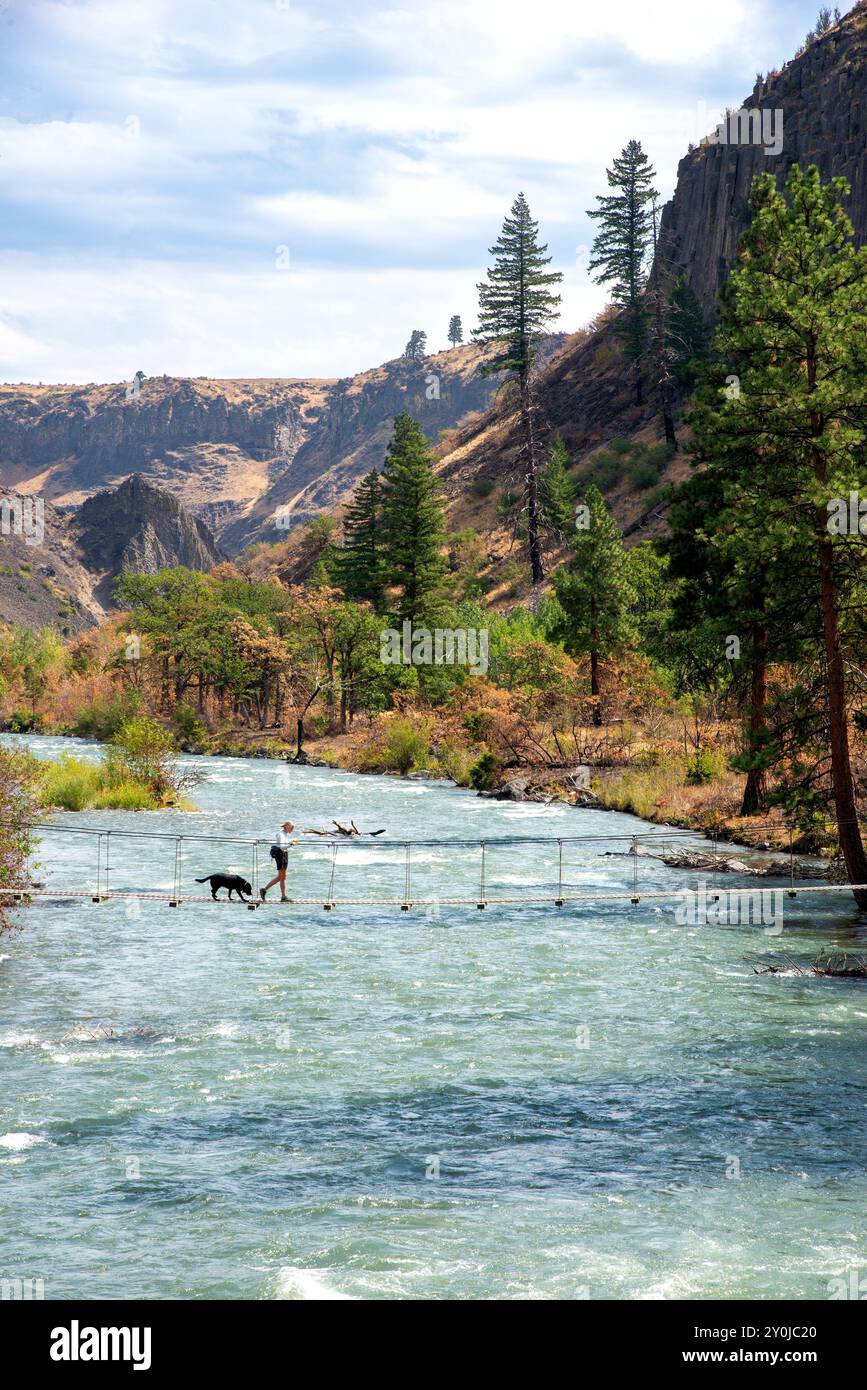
[553,482,635,724]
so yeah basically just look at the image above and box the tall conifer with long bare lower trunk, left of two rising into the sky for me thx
[472,193,563,584]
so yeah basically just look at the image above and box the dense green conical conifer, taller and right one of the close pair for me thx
[382,411,447,623]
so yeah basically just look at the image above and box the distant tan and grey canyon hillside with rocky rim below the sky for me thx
[0,335,563,553]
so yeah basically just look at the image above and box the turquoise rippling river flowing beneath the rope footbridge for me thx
[0,738,867,1300]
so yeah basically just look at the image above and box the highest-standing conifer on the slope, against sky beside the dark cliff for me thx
[588,140,657,404]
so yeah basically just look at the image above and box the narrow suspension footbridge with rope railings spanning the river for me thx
[0,821,867,912]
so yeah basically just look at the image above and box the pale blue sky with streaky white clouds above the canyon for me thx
[0,0,849,384]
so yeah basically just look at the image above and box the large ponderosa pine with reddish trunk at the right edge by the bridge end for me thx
[693,167,867,906]
